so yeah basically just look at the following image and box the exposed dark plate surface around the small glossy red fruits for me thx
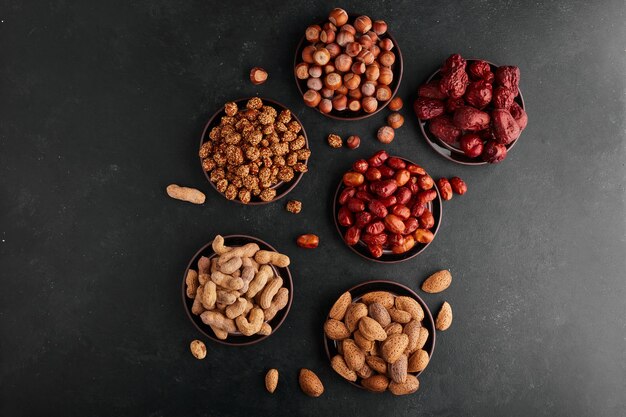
[333,155,443,264]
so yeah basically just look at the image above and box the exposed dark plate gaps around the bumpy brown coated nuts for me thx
[198,97,309,206]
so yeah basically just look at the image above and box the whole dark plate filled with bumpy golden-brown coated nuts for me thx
[199,97,311,205]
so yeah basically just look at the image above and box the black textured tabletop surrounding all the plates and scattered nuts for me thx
[0,0,626,417]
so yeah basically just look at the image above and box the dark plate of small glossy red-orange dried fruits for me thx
[333,151,443,263]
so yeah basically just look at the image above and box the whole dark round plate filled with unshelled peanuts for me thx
[182,235,293,346]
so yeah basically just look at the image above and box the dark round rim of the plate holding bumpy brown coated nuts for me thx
[198,96,310,206]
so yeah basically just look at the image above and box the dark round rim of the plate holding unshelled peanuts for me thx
[182,234,293,346]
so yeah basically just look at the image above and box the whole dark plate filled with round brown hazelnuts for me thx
[294,8,403,120]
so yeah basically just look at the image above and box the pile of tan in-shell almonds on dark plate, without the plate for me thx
[324,291,430,395]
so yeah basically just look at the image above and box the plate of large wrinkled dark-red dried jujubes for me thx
[413,54,528,165]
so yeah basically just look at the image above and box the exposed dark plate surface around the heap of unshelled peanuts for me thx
[182,235,293,346]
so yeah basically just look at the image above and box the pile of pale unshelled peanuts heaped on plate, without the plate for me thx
[185,235,290,340]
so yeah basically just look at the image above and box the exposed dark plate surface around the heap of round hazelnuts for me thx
[293,13,404,120]
